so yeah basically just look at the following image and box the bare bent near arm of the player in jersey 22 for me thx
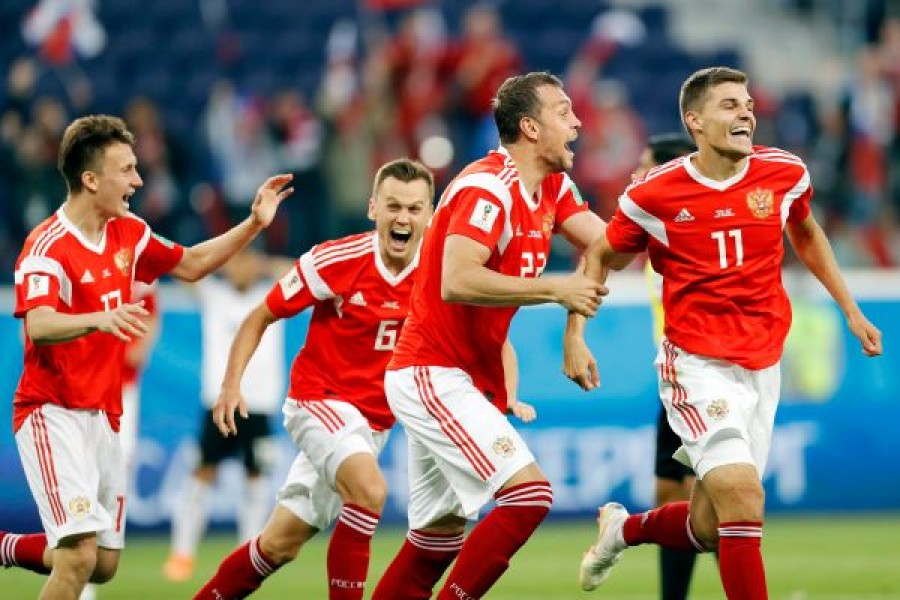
[441,235,606,316]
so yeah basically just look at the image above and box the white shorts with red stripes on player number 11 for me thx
[654,339,781,479]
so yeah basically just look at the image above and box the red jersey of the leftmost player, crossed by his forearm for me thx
[13,209,184,431]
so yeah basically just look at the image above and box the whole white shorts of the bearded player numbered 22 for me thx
[384,367,535,529]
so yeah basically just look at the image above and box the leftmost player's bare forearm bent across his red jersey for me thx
[25,301,149,344]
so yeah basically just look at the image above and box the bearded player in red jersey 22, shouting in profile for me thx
[373,73,605,600]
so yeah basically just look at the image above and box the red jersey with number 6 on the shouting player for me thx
[266,231,418,430]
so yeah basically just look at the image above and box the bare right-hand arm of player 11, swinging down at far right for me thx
[786,215,882,356]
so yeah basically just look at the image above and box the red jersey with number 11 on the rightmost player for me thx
[606,146,813,369]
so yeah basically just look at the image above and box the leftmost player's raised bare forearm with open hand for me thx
[172,175,294,281]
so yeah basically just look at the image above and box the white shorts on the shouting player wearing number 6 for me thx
[278,398,389,530]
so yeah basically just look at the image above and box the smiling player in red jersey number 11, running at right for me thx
[565,67,881,600]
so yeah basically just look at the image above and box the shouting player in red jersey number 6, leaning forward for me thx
[196,159,434,600]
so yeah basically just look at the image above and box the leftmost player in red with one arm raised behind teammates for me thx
[0,115,292,598]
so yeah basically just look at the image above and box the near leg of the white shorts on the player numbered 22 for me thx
[385,367,535,514]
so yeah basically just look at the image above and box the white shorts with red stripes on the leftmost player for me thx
[16,404,125,549]
